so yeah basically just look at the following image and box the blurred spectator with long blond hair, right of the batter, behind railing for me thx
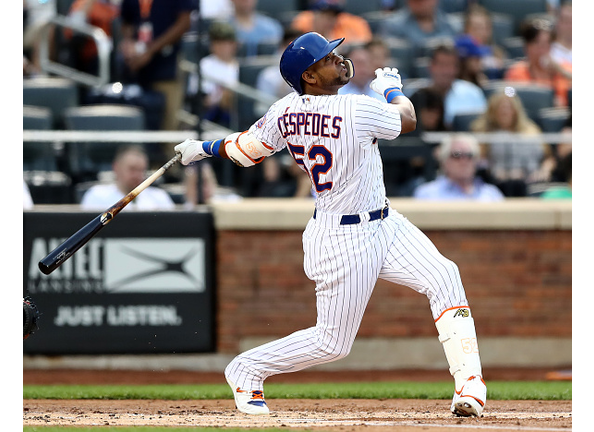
[471,88,551,196]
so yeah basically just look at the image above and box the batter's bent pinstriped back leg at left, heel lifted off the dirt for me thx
[225,224,383,412]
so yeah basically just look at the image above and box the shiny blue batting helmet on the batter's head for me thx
[280,32,354,94]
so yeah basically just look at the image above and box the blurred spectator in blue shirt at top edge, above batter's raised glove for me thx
[379,0,459,57]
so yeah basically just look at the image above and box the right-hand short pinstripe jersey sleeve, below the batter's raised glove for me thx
[354,95,402,147]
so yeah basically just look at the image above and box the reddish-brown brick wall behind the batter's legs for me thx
[217,230,572,353]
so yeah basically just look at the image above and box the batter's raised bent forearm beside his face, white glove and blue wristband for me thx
[369,67,417,133]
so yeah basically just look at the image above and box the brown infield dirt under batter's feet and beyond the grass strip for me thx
[23,370,572,432]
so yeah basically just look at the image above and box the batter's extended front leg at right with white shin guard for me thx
[379,214,486,416]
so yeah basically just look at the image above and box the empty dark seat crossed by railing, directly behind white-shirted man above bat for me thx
[65,104,145,180]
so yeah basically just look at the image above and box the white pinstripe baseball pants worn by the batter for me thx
[225,209,468,390]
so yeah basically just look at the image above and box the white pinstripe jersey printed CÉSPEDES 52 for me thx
[250,92,401,214]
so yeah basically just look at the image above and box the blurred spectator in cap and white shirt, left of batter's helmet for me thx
[188,21,239,127]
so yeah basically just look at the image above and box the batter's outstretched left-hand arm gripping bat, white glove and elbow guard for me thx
[174,131,275,167]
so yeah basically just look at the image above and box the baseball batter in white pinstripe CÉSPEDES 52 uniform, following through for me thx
[175,32,487,416]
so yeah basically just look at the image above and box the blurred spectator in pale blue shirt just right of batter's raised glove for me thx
[404,45,487,129]
